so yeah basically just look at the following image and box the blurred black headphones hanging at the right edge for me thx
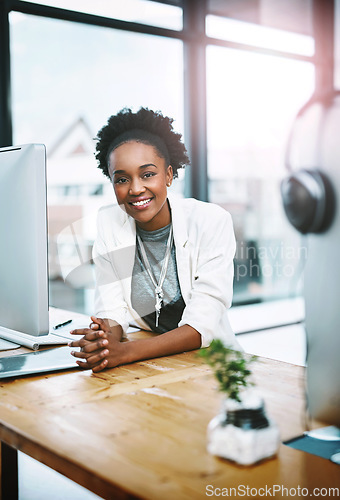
[281,91,340,234]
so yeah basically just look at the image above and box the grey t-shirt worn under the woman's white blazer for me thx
[131,224,185,333]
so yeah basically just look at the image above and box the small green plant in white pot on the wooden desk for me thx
[198,340,280,465]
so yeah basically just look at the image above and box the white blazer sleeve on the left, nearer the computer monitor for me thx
[93,211,129,333]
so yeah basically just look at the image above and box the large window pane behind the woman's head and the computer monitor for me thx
[10,13,183,312]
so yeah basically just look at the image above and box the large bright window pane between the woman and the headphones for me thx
[207,46,314,303]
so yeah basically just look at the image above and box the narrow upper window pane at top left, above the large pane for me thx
[18,0,183,30]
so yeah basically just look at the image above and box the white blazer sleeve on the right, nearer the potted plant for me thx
[179,207,236,347]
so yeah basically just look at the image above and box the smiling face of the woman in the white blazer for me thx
[109,141,173,231]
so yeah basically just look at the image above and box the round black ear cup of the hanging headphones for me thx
[281,170,335,234]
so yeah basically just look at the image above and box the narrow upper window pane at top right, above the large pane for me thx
[206,15,314,56]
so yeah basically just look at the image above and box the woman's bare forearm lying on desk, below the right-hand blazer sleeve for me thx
[122,325,201,364]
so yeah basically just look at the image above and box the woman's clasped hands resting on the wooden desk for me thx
[68,316,124,373]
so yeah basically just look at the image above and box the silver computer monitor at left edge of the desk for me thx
[0,144,49,336]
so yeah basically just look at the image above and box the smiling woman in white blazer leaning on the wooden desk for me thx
[69,108,238,372]
